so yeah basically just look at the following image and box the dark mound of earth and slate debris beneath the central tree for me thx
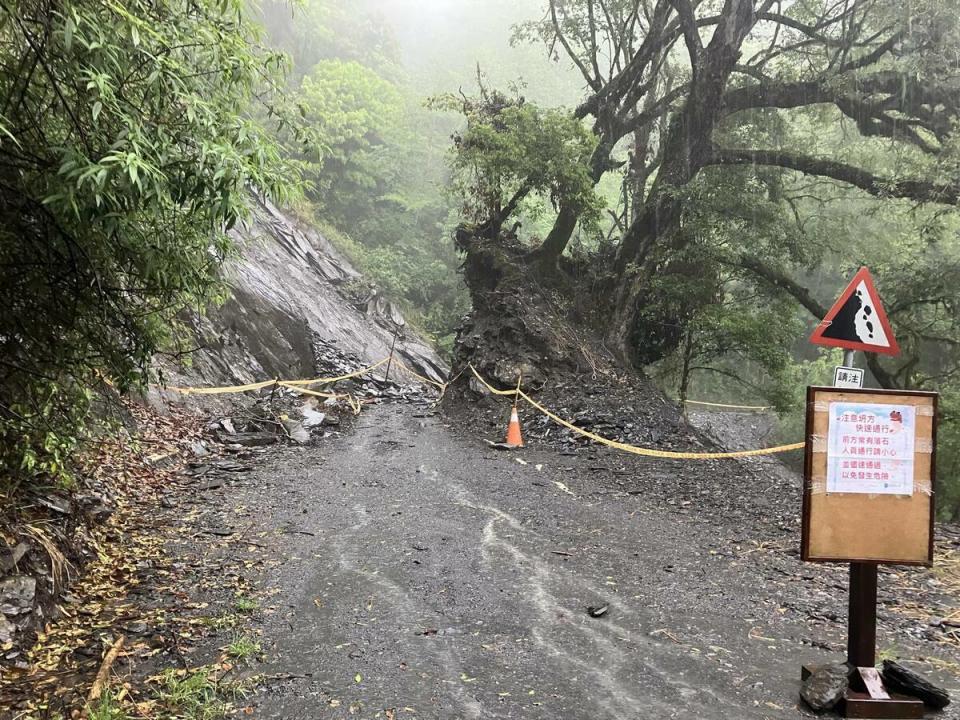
[445,234,718,452]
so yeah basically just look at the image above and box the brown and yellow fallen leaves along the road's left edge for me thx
[0,404,253,719]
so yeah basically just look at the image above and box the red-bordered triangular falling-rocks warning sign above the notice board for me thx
[810,268,900,355]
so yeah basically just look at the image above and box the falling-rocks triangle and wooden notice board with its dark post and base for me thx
[801,268,937,718]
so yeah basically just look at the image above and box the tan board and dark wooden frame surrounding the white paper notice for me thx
[800,387,938,567]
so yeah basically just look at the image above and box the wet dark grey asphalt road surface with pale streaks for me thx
[218,406,944,720]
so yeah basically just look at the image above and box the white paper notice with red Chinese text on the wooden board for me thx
[827,402,917,495]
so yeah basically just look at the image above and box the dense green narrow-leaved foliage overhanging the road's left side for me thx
[0,0,294,490]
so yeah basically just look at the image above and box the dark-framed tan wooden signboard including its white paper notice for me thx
[801,387,937,566]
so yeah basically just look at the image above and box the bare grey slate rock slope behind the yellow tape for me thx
[161,194,447,384]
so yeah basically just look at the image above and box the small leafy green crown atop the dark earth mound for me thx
[433,85,602,227]
